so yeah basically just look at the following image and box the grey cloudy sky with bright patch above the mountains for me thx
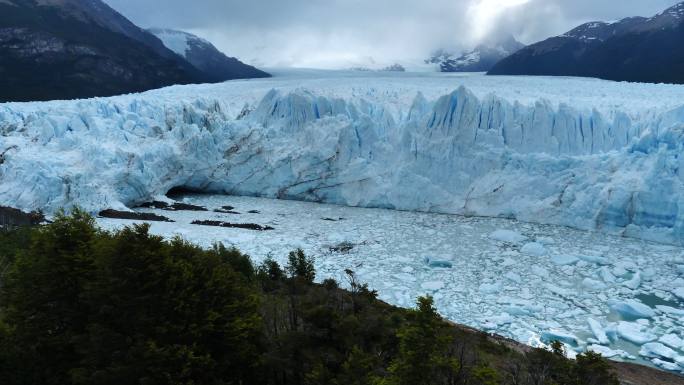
[105,0,677,68]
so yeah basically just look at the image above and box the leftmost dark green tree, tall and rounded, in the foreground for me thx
[0,209,98,385]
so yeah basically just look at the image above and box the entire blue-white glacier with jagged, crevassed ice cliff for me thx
[0,74,684,243]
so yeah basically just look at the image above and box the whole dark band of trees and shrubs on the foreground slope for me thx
[0,211,618,385]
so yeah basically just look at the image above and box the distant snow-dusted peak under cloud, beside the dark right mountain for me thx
[426,36,525,72]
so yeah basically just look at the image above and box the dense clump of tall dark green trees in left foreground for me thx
[0,210,263,385]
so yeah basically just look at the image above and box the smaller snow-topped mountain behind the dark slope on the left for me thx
[148,28,270,82]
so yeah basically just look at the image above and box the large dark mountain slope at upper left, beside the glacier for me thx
[0,0,207,102]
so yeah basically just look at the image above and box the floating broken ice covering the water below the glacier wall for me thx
[98,195,684,372]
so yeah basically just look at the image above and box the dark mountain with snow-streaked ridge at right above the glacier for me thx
[489,2,684,84]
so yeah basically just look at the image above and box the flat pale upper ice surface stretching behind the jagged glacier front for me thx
[0,68,684,118]
